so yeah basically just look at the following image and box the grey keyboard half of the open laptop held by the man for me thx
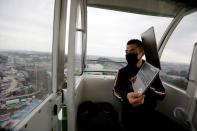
[132,62,160,93]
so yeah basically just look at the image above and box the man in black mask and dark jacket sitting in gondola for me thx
[113,39,165,131]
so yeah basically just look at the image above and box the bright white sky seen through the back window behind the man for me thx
[87,7,172,57]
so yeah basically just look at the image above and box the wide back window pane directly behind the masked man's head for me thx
[86,7,172,74]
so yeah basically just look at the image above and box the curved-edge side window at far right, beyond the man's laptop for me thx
[161,12,197,90]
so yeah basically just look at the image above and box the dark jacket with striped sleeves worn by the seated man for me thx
[113,61,166,110]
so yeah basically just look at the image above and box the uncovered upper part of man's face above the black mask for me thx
[125,44,144,60]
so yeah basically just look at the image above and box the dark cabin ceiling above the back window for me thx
[87,0,197,17]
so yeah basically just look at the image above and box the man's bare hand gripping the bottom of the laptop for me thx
[127,92,145,107]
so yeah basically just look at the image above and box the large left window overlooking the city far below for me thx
[0,0,54,129]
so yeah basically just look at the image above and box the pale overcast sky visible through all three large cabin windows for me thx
[0,0,197,62]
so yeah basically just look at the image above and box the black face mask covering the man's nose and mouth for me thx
[126,53,138,66]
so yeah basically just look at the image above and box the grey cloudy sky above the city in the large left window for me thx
[0,0,54,51]
